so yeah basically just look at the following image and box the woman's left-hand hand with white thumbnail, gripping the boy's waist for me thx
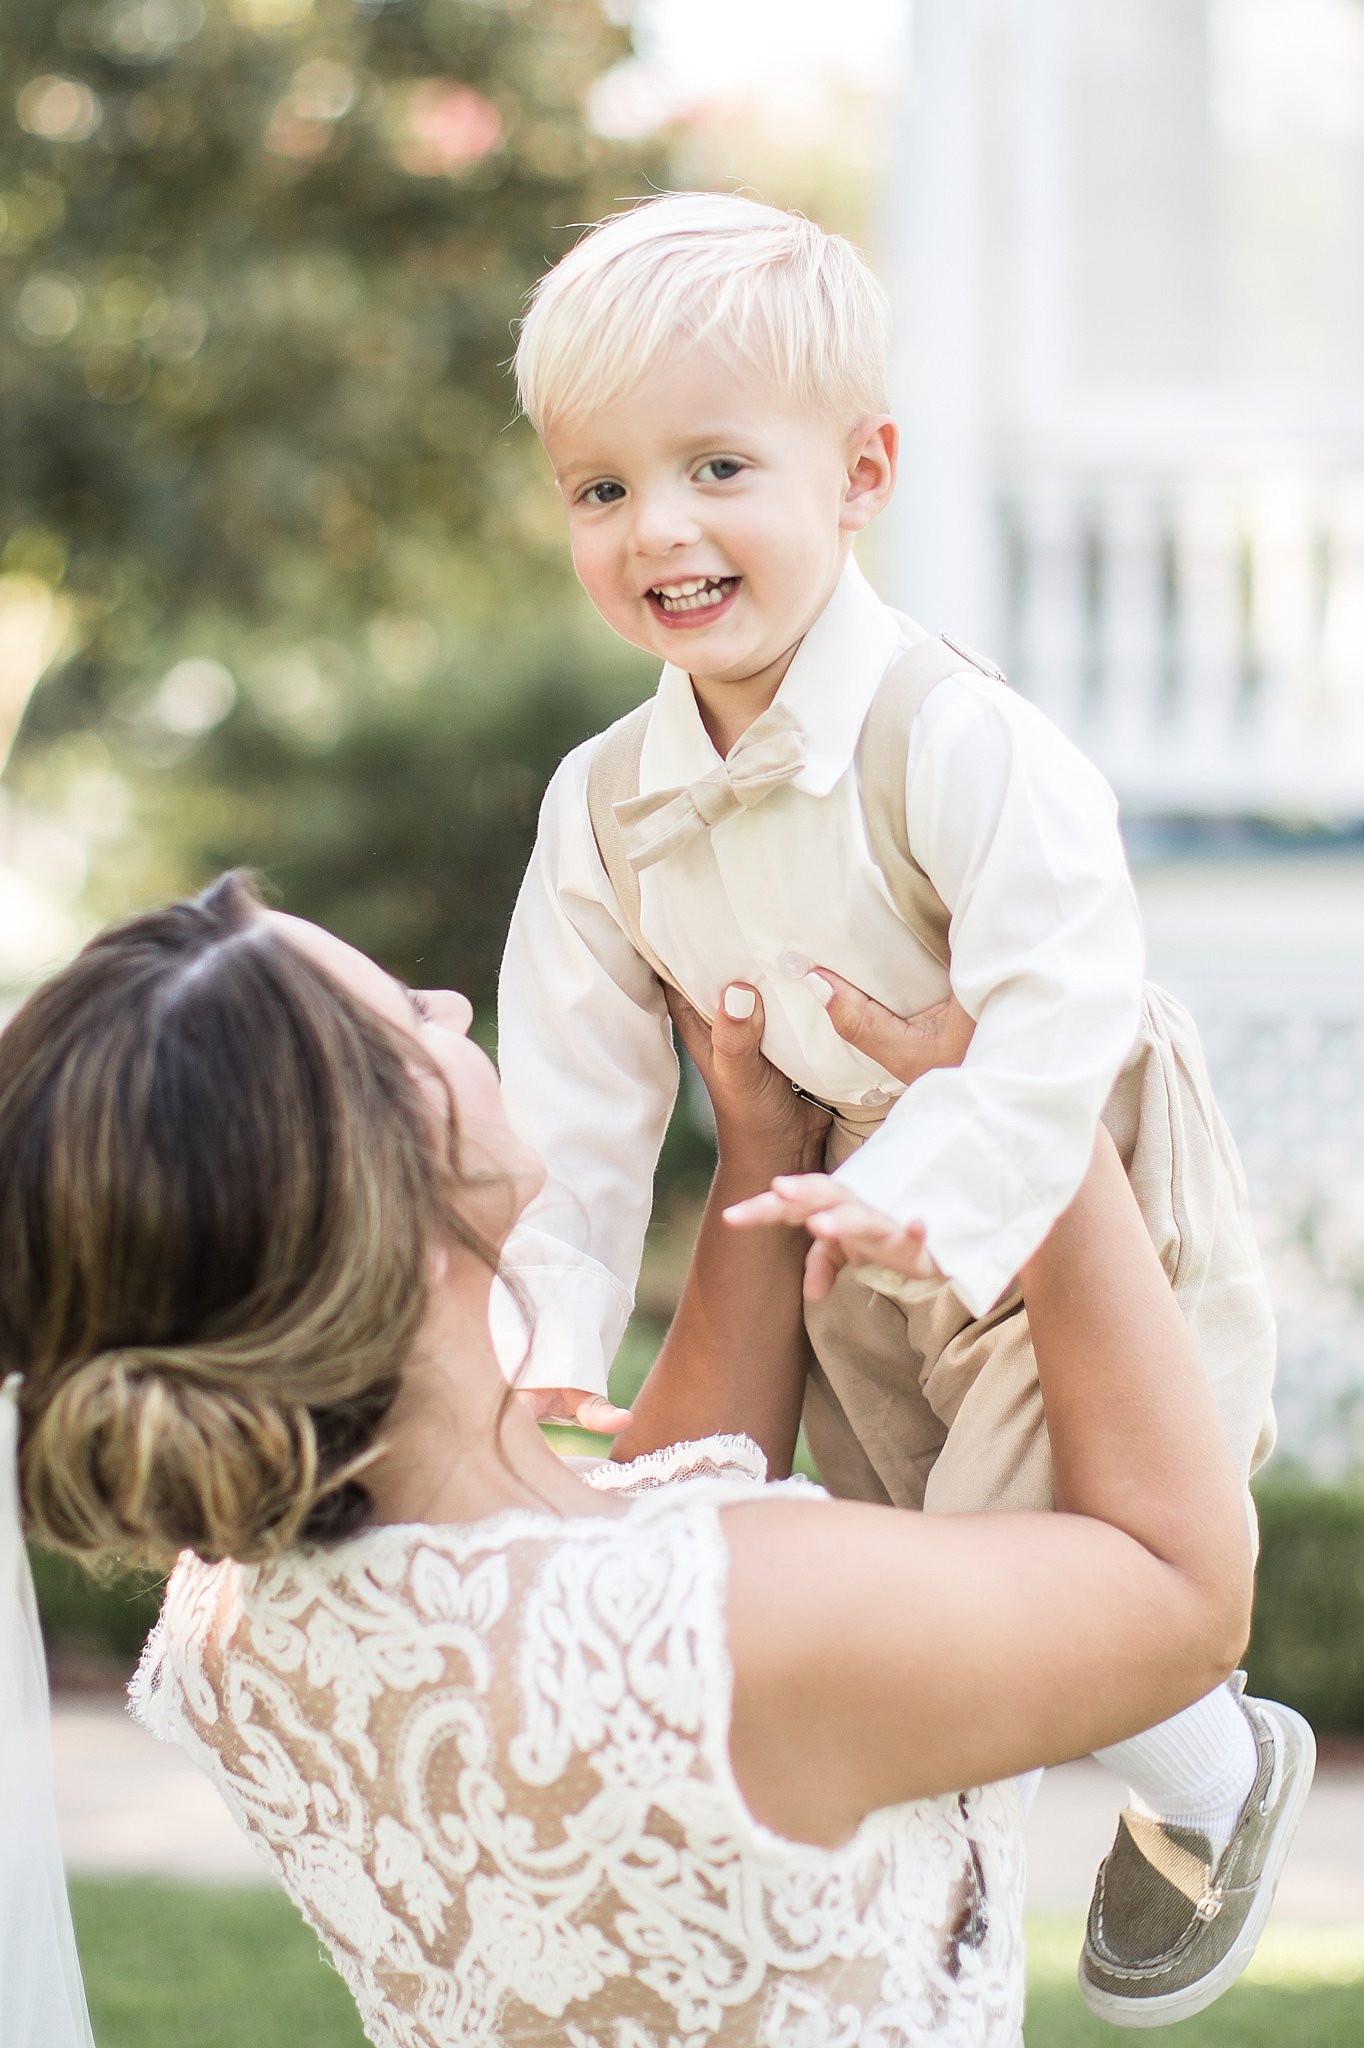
[668,981,829,1178]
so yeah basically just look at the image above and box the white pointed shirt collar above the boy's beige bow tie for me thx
[639,555,915,797]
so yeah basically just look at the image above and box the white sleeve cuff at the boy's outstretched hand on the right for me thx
[834,1116,1044,1317]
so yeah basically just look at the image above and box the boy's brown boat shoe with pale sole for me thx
[1079,1671,1317,2028]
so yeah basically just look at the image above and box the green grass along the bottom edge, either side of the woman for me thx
[72,1878,1364,2048]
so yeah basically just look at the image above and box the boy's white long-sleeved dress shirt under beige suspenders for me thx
[500,561,1143,1391]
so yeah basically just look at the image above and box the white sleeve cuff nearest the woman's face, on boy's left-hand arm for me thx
[487,1247,633,1395]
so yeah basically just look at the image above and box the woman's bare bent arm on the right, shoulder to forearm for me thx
[725,991,1251,1841]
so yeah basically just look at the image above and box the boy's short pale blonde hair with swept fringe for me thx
[516,193,889,434]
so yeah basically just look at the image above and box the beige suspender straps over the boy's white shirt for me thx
[588,639,999,989]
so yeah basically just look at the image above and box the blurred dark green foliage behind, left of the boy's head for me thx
[0,0,666,1006]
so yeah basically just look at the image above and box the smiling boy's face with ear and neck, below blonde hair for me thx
[545,344,895,715]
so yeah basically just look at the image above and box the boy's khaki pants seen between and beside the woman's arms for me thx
[805,985,1274,1522]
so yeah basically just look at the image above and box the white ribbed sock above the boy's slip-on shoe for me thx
[1094,1686,1260,1849]
